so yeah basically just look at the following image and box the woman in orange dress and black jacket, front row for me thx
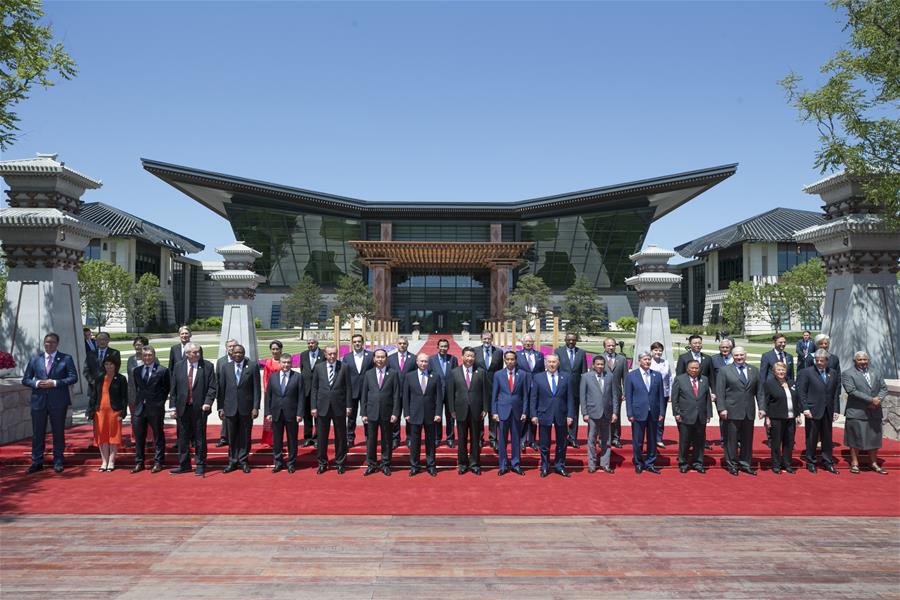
[87,356,128,471]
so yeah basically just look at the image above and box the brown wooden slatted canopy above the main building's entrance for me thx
[348,241,533,269]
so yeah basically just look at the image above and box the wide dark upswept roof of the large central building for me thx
[141,159,737,220]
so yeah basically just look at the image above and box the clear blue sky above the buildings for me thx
[3,1,847,259]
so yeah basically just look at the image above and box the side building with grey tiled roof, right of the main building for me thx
[675,208,825,333]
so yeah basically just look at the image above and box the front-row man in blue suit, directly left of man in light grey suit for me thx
[528,354,580,477]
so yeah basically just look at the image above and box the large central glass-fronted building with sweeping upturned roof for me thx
[143,159,737,332]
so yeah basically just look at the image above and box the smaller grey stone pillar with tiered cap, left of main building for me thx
[211,242,265,362]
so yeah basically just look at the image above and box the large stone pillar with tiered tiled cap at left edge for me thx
[0,154,109,408]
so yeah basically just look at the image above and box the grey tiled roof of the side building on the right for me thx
[675,208,825,258]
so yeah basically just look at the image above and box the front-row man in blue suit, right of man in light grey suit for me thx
[625,352,666,475]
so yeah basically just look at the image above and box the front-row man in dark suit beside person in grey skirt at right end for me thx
[797,350,841,474]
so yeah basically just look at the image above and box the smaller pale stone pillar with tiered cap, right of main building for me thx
[625,245,681,369]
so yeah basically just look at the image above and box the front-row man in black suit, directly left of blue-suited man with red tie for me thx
[448,346,491,475]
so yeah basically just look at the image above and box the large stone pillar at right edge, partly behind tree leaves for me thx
[794,173,900,379]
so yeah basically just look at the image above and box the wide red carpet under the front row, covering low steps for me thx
[0,426,900,517]
